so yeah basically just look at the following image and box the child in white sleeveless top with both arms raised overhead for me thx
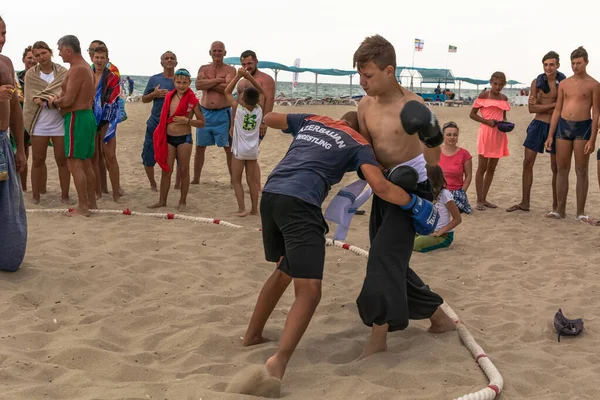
[224,68,265,217]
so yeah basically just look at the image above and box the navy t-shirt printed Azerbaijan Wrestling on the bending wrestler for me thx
[263,114,379,207]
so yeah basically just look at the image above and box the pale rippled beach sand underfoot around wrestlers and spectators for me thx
[0,103,600,400]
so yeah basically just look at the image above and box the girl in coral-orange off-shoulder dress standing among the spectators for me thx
[470,72,510,211]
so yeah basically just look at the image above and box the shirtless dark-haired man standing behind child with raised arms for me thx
[237,50,275,193]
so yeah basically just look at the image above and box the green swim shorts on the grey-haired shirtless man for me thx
[63,110,96,160]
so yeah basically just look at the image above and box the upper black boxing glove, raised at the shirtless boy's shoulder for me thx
[400,100,444,148]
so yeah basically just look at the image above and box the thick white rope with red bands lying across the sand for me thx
[27,209,504,400]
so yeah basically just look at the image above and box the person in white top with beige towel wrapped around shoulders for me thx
[23,41,71,204]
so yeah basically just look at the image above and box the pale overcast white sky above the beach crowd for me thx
[0,0,600,87]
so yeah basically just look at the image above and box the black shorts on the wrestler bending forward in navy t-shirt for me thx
[260,192,329,279]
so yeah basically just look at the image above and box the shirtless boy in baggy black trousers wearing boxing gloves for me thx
[354,35,456,359]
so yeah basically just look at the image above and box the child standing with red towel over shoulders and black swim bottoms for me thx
[148,68,204,211]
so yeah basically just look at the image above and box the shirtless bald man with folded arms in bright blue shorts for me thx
[191,42,236,185]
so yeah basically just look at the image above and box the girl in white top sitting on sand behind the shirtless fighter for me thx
[413,165,462,253]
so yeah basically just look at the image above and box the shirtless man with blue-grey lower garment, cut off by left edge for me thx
[0,17,27,271]
